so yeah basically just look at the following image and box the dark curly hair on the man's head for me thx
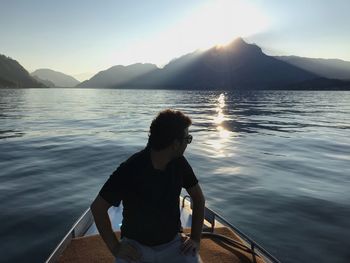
[148,109,192,151]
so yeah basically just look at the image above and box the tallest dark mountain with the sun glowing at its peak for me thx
[149,38,316,89]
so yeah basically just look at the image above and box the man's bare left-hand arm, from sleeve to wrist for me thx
[90,195,120,257]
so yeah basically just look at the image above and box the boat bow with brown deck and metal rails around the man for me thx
[46,196,279,263]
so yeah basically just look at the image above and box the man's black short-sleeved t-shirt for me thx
[99,147,198,246]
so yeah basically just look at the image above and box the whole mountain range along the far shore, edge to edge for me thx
[0,38,350,90]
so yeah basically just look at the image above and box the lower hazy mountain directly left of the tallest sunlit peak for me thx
[76,63,158,88]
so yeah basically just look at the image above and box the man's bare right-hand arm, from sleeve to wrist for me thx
[187,184,205,243]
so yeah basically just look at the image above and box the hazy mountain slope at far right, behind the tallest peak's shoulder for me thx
[275,56,350,80]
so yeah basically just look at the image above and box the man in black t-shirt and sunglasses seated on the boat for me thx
[91,109,205,263]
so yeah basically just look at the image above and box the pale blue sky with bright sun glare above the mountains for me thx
[0,0,350,80]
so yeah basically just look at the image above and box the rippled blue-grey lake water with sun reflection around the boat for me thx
[0,89,350,262]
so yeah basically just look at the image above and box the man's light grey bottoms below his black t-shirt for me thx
[115,233,202,263]
